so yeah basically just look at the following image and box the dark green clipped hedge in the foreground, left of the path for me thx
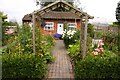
[2,53,47,79]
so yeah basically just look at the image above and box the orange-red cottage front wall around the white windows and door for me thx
[40,20,80,35]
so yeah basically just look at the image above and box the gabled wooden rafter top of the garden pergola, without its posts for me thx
[31,0,94,19]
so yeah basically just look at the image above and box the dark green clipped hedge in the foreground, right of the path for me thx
[75,52,120,79]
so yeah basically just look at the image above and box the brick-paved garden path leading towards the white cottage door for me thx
[47,40,74,80]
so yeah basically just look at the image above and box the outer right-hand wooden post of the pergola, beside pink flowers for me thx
[83,16,88,59]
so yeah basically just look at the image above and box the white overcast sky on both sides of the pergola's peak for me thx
[0,0,120,23]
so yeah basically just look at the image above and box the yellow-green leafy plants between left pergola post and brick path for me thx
[37,35,54,63]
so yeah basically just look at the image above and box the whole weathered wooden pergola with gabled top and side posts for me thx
[31,0,93,58]
